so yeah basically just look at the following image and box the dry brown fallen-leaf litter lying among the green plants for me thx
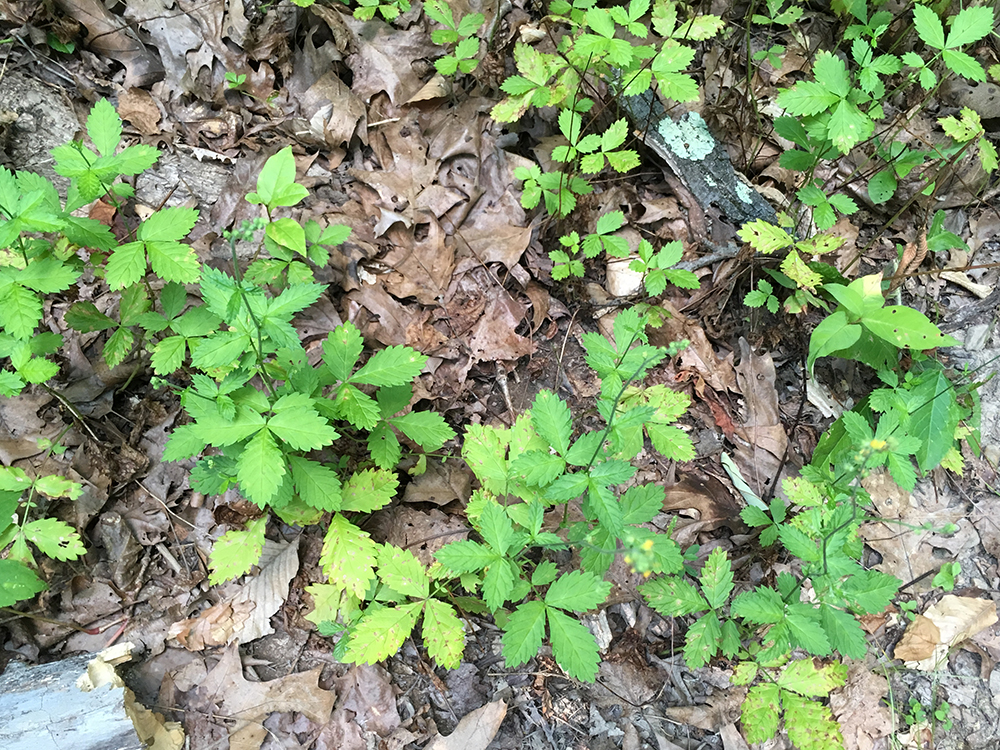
[0,0,997,750]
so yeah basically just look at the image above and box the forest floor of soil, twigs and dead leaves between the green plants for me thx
[0,0,1000,750]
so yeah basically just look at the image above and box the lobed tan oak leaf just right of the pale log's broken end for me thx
[196,643,335,750]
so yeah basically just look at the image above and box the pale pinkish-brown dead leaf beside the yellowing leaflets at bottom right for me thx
[830,661,892,750]
